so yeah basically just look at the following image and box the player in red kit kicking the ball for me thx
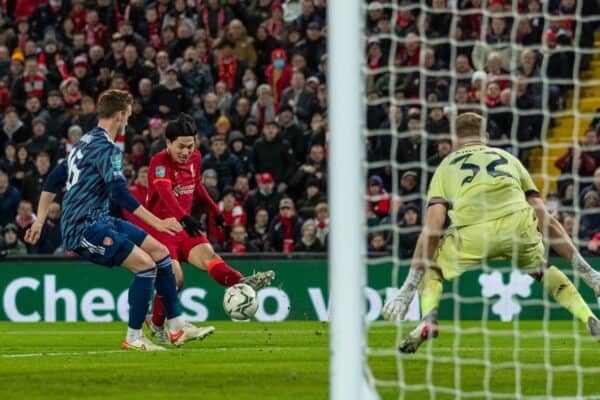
[143,114,275,343]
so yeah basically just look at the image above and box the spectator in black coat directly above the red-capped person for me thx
[253,121,296,192]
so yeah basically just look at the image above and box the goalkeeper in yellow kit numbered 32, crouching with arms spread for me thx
[383,112,600,353]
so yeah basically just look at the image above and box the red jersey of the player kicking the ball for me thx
[146,150,220,220]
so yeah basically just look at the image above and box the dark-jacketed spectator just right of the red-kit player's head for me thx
[202,135,244,190]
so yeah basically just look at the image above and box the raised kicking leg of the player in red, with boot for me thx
[181,237,275,290]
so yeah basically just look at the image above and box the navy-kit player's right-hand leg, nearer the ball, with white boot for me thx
[115,220,214,346]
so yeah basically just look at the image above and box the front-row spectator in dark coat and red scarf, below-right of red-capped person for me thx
[269,197,303,253]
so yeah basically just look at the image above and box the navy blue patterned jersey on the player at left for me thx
[61,127,124,250]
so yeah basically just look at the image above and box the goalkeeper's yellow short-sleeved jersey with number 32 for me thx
[427,145,538,226]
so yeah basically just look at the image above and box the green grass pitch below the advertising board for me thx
[0,321,600,400]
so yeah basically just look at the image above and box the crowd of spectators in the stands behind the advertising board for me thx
[0,0,600,257]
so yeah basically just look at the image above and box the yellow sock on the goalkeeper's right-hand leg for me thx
[542,266,594,324]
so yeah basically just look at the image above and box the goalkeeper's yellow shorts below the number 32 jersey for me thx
[434,208,545,280]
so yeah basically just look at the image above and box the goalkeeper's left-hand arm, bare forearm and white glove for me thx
[382,203,447,321]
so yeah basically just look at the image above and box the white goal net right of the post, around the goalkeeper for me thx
[360,0,600,399]
